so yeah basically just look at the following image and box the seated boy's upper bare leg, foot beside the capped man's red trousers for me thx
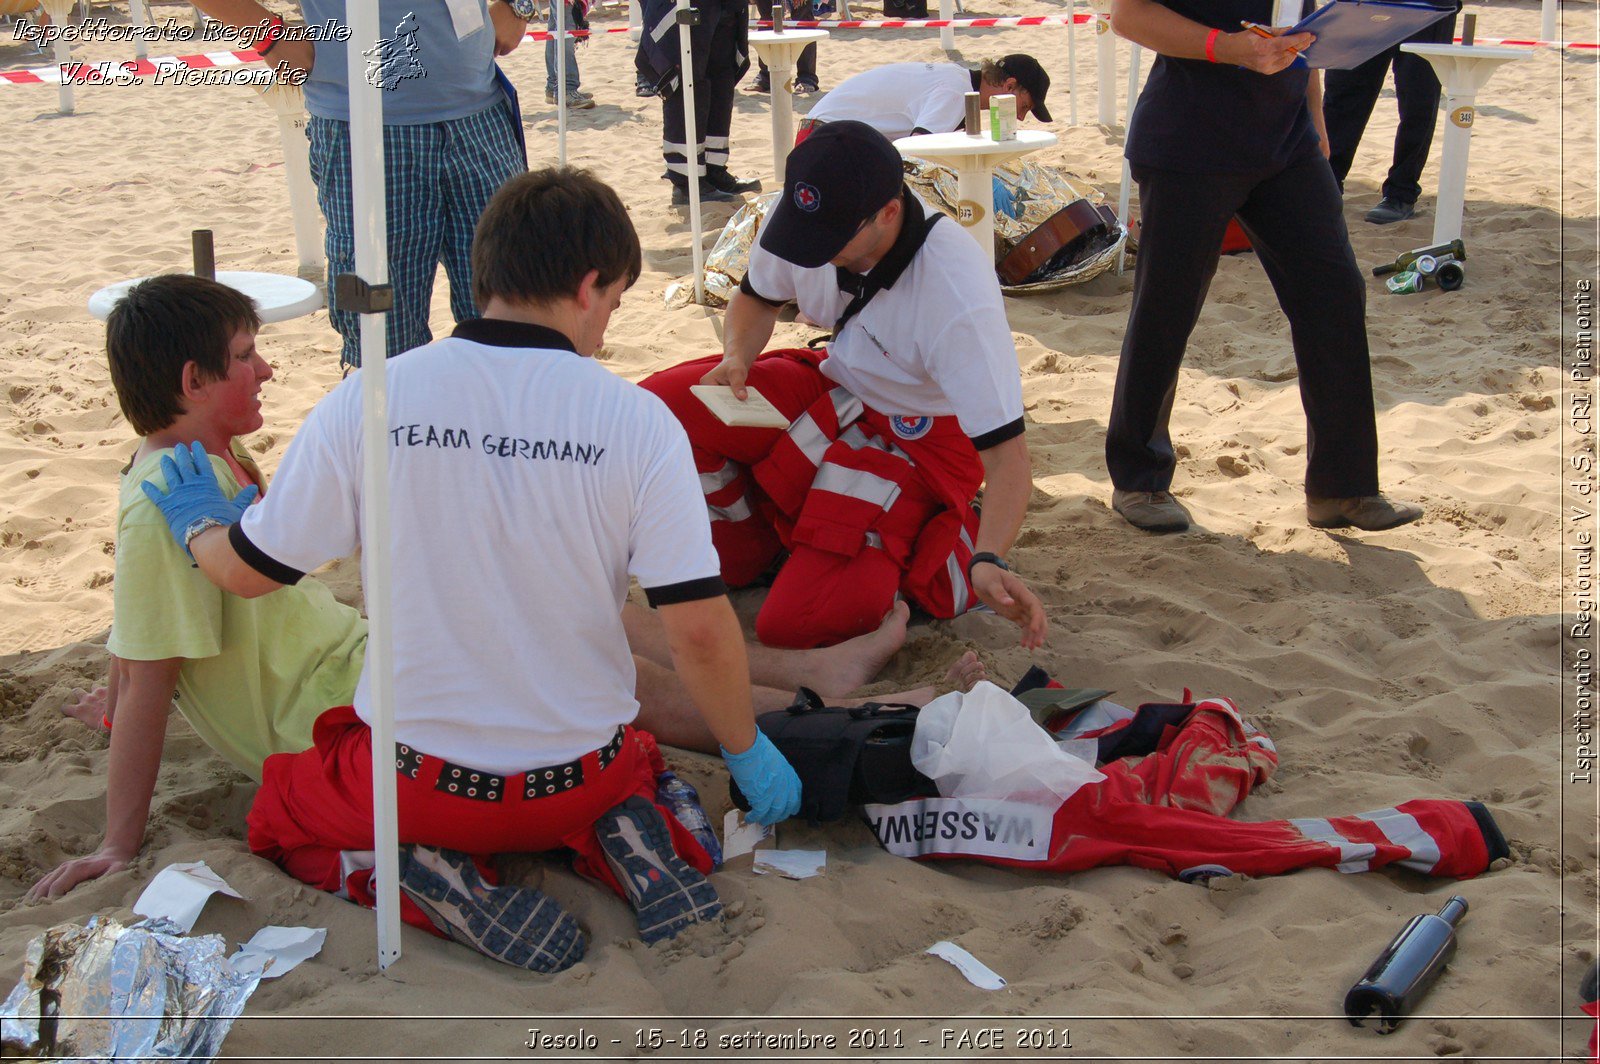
[622,602,910,697]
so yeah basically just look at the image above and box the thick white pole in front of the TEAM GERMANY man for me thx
[341,3,400,970]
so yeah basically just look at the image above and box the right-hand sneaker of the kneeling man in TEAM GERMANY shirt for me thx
[595,795,722,946]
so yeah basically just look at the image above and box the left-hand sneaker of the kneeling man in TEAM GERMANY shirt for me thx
[400,846,589,973]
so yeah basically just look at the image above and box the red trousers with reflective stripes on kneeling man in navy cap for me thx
[643,350,984,648]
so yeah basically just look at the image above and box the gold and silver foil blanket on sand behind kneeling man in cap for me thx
[666,158,1133,309]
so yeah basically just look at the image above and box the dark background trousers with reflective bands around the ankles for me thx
[661,0,747,181]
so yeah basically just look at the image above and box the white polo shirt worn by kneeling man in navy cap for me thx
[746,195,1022,450]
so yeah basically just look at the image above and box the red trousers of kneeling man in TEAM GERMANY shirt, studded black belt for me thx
[248,706,710,931]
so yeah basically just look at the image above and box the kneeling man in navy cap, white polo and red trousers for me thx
[643,122,1045,646]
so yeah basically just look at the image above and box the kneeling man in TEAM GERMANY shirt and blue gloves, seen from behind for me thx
[147,170,800,971]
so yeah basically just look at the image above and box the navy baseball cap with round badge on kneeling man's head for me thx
[762,122,906,269]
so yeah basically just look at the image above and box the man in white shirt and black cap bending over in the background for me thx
[795,53,1050,144]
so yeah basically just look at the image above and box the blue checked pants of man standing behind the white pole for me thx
[306,101,526,366]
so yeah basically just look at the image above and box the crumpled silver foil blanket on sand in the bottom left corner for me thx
[0,915,261,1061]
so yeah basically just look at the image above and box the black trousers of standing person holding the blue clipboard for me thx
[1106,154,1378,498]
